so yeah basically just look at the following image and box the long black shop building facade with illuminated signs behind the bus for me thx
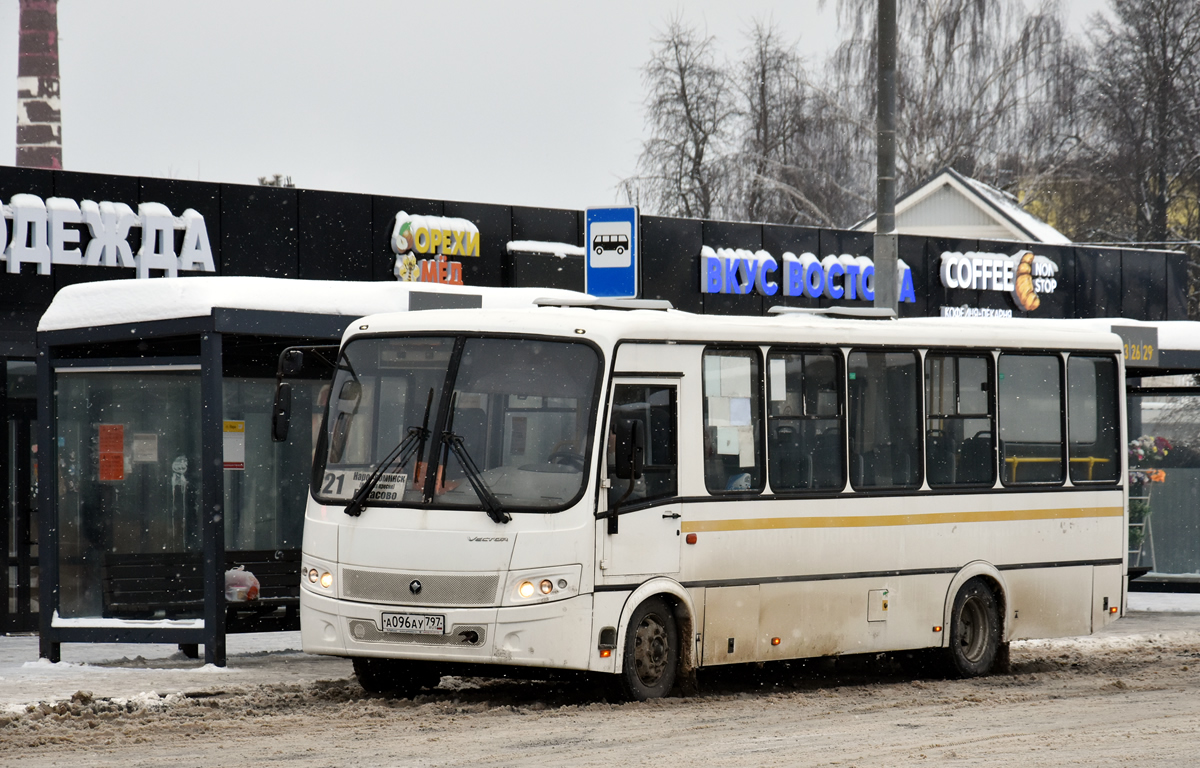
[0,167,1187,642]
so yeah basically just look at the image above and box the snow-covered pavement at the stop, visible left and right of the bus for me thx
[0,593,1200,714]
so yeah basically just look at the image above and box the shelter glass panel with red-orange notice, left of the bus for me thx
[54,368,203,618]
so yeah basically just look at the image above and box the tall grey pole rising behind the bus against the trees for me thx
[874,0,900,313]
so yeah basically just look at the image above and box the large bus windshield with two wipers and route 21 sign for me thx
[313,336,599,511]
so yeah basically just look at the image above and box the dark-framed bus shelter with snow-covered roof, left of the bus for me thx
[37,277,580,666]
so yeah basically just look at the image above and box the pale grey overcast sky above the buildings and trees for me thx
[0,0,1104,209]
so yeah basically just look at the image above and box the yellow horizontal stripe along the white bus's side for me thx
[683,506,1124,533]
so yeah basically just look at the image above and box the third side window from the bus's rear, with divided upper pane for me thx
[925,354,996,487]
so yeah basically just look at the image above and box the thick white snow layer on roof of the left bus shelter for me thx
[37,277,587,331]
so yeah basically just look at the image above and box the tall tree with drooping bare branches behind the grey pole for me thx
[828,0,1079,206]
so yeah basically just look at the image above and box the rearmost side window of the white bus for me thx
[1067,355,1121,482]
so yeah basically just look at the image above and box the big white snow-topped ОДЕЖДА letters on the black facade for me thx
[0,194,216,278]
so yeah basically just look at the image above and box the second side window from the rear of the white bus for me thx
[996,354,1066,485]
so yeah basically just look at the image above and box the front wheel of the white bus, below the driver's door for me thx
[619,598,679,701]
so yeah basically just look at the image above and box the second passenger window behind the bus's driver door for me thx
[767,349,846,491]
